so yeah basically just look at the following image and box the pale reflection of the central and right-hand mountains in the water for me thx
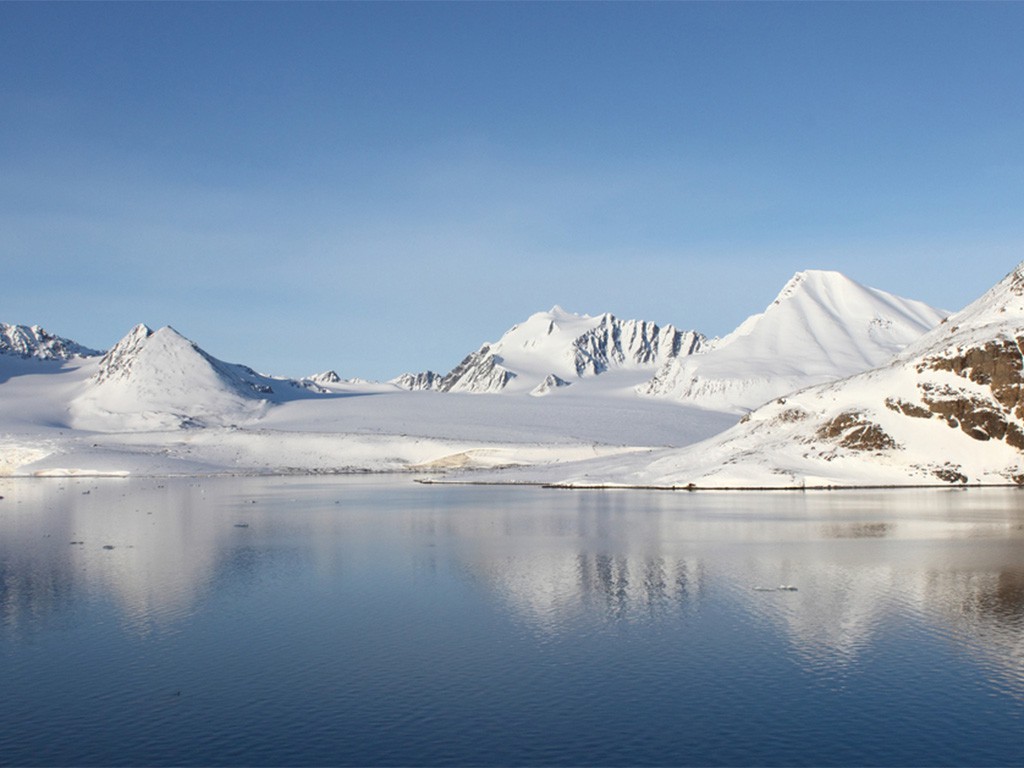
[432,490,1024,695]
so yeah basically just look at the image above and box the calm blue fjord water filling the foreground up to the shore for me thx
[0,478,1024,765]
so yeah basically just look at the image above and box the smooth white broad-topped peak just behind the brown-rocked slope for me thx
[638,270,947,413]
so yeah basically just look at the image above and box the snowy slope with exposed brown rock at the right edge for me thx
[552,264,1024,487]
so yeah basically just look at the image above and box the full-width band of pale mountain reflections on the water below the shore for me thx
[0,478,1024,695]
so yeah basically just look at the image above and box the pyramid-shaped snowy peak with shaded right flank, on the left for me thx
[71,325,299,431]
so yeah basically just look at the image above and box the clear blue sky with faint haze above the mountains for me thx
[0,2,1024,379]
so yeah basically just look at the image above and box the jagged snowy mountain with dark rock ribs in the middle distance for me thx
[393,306,705,395]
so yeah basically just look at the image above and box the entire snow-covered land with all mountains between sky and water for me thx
[18,264,1024,488]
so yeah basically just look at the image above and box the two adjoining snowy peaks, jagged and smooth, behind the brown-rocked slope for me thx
[392,270,948,405]
